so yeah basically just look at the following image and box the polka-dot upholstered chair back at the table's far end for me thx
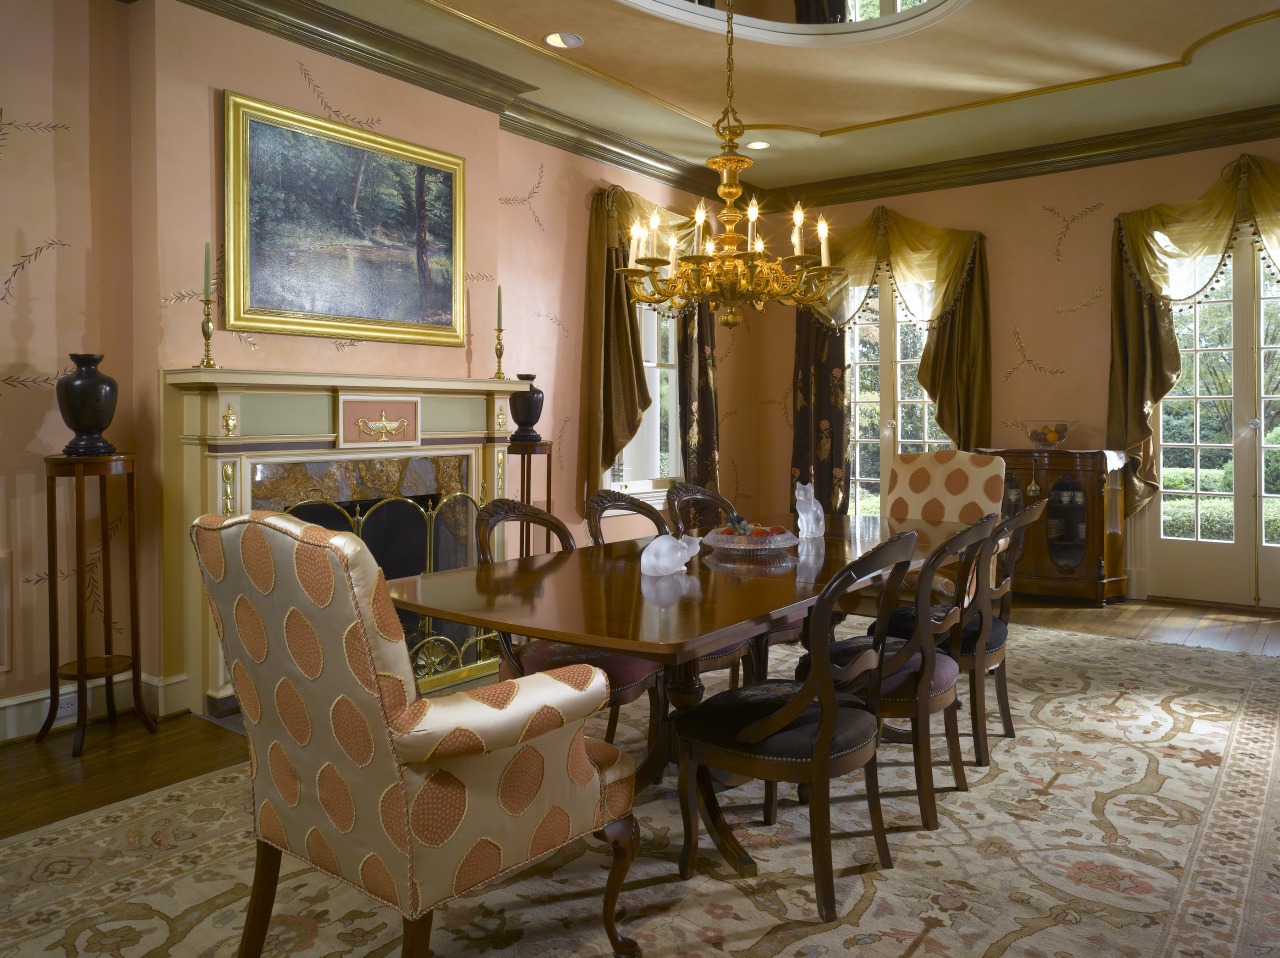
[886,450,1005,523]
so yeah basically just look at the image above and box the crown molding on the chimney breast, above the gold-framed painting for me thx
[182,0,536,113]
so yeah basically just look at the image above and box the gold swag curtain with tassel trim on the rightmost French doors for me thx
[1107,154,1280,515]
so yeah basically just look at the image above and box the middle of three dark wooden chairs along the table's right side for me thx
[796,515,997,830]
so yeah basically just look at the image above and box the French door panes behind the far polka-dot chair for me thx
[847,272,951,516]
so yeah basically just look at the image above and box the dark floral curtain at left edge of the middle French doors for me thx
[791,309,850,514]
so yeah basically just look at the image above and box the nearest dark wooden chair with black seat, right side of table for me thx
[675,533,915,921]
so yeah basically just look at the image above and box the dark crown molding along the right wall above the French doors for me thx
[762,104,1280,209]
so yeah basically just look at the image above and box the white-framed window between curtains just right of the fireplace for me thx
[611,304,685,502]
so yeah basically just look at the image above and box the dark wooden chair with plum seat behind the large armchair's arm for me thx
[476,498,667,751]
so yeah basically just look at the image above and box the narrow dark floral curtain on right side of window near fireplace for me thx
[676,304,721,492]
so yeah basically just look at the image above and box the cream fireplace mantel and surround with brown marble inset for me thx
[160,369,527,715]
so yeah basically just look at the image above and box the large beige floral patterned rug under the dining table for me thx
[0,628,1280,958]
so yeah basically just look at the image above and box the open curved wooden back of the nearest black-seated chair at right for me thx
[737,532,915,761]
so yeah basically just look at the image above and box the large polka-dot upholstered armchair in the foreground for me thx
[191,512,636,957]
